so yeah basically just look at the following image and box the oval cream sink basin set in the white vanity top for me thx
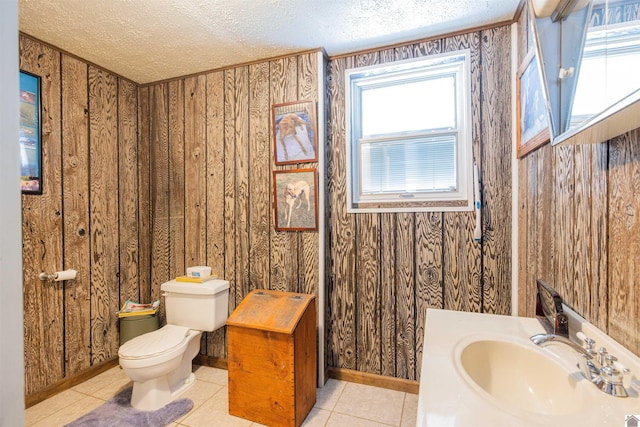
[456,338,585,415]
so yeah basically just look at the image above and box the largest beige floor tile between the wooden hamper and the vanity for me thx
[334,383,404,426]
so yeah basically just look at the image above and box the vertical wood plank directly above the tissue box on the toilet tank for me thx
[184,74,207,267]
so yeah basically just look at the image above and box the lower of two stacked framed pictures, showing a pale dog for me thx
[273,169,318,231]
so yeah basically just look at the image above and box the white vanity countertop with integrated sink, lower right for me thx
[416,307,640,427]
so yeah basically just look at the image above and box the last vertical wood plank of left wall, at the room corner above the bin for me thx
[117,79,140,305]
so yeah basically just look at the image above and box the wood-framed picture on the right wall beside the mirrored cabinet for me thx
[516,48,550,158]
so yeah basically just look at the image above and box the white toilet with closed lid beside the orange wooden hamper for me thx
[118,280,229,411]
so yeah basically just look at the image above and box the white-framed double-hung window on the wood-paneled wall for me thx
[345,50,473,212]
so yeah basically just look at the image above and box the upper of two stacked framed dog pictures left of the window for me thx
[271,101,318,165]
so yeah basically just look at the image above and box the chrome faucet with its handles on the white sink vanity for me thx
[531,334,628,397]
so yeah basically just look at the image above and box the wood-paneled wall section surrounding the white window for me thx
[326,26,512,379]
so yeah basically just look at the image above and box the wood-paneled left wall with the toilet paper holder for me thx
[20,36,141,394]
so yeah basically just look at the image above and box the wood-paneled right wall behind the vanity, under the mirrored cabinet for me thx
[518,8,640,355]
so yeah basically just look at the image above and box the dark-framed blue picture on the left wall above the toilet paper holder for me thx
[19,71,42,194]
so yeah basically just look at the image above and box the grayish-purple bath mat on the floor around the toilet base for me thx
[65,387,193,427]
